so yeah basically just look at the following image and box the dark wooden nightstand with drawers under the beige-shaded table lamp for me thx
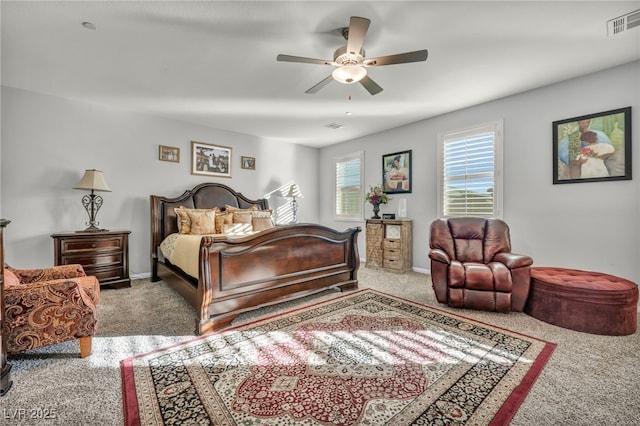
[51,230,131,288]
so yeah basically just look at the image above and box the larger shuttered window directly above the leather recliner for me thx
[438,121,503,217]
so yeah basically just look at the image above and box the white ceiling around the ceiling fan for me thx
[0,0,640,147]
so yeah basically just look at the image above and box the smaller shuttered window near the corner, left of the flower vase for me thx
[333,151,364,220]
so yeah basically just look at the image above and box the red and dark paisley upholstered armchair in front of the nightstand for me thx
[4,265,100,358]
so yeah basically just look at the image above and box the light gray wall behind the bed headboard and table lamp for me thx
[0,87,319,275]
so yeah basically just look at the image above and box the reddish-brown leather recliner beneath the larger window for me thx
[429,217,533,312]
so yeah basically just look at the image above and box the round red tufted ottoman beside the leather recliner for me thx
[524,266,638,336]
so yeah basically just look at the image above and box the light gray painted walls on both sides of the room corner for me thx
[0,62,640,282]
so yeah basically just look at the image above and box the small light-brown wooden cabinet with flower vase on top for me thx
[365,219,413,272]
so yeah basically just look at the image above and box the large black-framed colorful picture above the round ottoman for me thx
[553,107,631,184]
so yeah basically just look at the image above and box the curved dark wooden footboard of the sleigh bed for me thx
[196,224,360,334]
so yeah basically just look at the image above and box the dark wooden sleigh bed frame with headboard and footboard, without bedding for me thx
[151,183,360,334]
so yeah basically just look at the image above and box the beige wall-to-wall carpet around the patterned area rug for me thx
[0,268,640,426]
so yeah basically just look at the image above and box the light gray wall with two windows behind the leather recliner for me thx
[320,62,640,283]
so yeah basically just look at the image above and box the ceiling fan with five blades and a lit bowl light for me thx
[276,16,428,95]
